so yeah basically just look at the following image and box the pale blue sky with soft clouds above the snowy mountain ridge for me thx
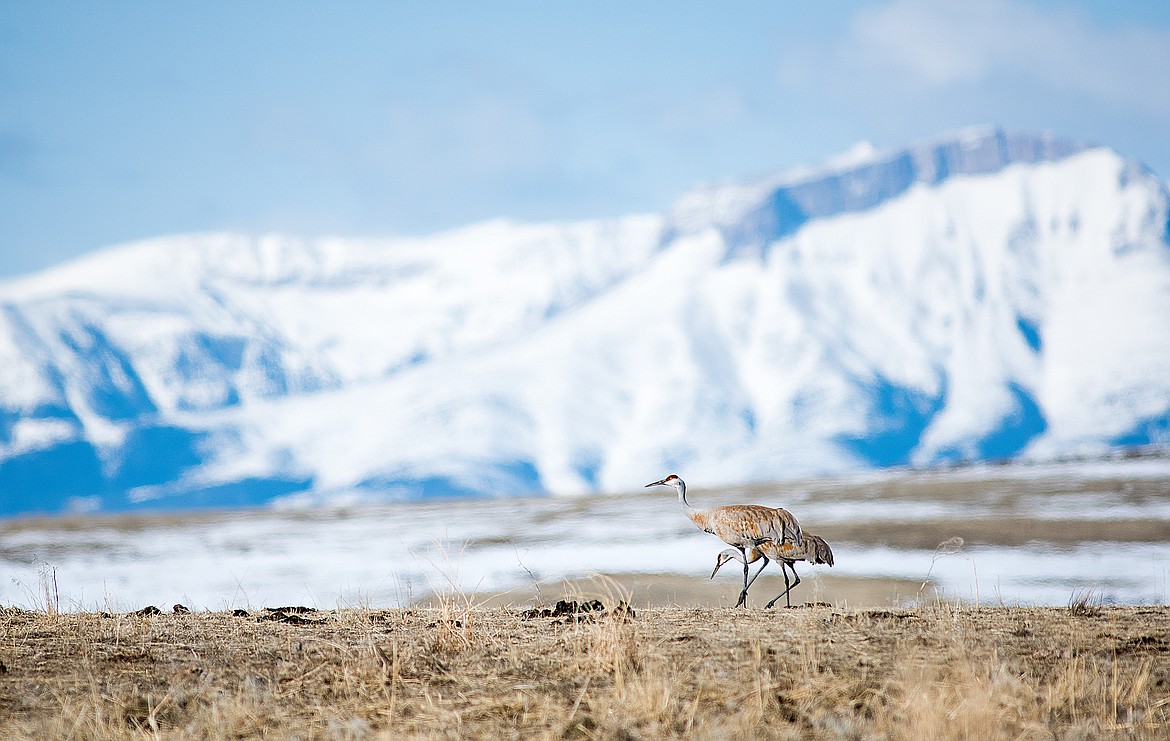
[0,0,1170,277]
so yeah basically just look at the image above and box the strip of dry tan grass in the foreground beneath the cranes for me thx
[0,595,1170,739]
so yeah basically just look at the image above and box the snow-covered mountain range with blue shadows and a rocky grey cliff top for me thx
[0,129,1170,513]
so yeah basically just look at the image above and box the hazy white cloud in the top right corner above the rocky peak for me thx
[779,0,1170,118]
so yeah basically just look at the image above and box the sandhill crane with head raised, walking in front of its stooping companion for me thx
[646,473,803,608]
